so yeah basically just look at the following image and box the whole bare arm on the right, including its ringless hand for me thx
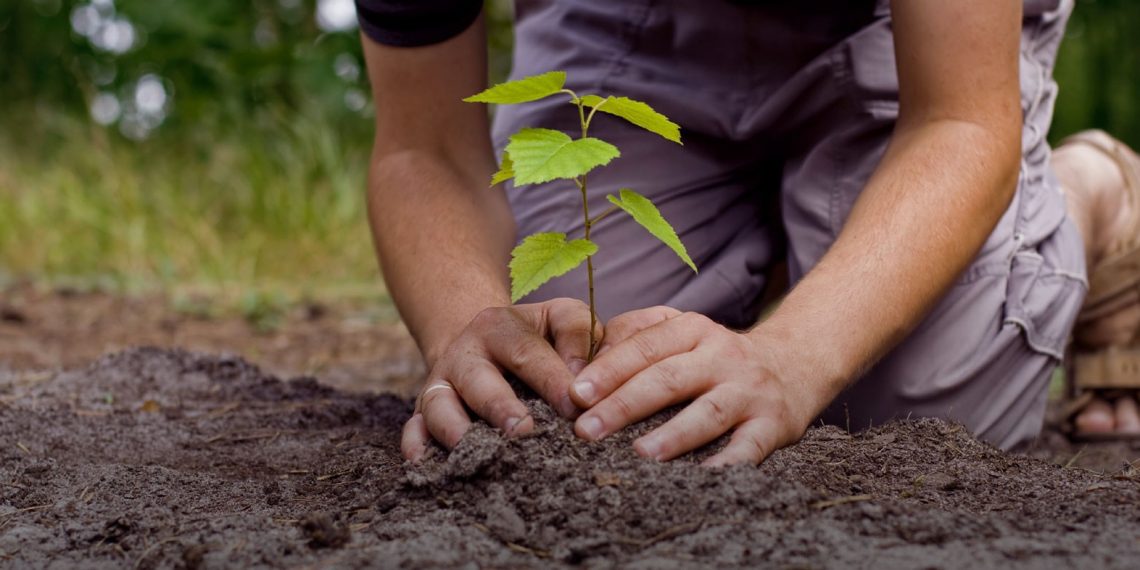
[572,0,1021,464]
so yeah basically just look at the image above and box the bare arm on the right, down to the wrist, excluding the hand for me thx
[757,0,1021,404]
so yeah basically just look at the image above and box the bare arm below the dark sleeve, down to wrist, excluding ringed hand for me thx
[361,17,514,367]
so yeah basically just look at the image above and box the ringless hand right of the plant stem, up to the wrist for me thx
[570,307,825,466]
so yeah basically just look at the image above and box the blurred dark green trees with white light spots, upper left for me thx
[0,0,369,138]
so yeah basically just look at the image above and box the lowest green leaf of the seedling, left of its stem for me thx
[511,233,597,303]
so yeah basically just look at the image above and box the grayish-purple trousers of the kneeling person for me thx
[494,0,1088,448]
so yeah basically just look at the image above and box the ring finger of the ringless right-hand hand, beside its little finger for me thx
[634,389,748,461]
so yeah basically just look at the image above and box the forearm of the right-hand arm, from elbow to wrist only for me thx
[751,120,1019,412]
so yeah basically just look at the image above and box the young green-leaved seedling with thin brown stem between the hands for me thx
[463,72,697,360]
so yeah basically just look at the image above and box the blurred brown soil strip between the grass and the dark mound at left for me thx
[0,284,424,396]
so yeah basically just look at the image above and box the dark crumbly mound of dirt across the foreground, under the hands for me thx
[0,349,1140,569]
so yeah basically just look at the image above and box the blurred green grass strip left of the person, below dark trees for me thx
[0,102,381,296]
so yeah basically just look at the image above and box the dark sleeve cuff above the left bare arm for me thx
[356,0,483,48]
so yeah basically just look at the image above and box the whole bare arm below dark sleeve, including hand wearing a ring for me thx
[363,17,589,459]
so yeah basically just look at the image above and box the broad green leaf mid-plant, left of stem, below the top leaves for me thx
[506,129,621,184]
